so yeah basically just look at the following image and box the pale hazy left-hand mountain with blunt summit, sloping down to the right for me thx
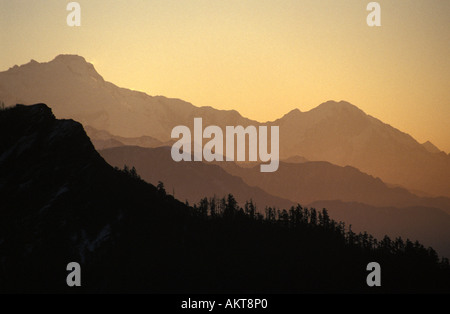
[0,55,253,142]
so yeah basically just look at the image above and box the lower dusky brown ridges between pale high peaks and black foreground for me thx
[99,146,450,256]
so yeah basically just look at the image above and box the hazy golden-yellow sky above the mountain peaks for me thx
[0,0,450,152]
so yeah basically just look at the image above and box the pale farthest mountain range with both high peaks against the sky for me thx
[0,55,450,197]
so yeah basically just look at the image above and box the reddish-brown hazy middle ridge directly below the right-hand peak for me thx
[218,161,450,214]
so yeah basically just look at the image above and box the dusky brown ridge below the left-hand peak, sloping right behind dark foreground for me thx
[99,146,295,212]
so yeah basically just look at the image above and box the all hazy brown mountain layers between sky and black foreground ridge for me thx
[0,55,450,256]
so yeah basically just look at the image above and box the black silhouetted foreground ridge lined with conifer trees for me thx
[0,104,450,293]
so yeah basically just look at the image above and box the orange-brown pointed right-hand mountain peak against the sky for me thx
[273,101,450,196]
